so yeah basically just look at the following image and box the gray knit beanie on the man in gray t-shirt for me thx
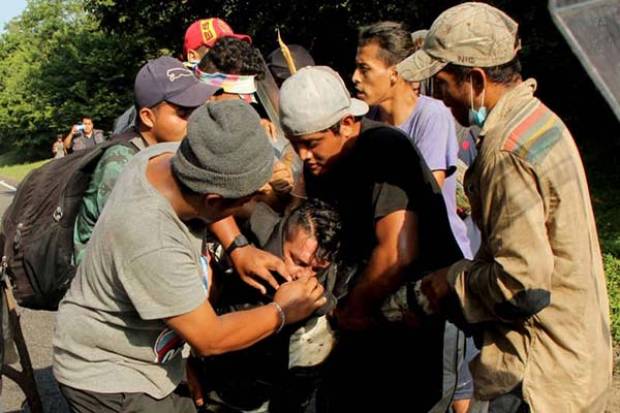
[172,100,274,199]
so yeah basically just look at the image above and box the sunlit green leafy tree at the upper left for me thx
[0,0,136,157]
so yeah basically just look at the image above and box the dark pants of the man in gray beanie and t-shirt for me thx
[60,384,196,413]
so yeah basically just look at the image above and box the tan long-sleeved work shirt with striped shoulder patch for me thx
[448,79,612,413]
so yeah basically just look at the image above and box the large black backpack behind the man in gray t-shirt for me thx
[0,131,144,310]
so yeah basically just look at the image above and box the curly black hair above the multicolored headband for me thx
[198,37,265,80]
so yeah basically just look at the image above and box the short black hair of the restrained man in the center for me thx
[284,198,342,262]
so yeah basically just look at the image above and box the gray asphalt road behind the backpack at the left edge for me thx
[0,183,69,413]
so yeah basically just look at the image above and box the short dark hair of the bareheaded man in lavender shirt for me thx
[358,21,414,66]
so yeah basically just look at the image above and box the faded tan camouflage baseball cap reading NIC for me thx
[396,3,520,82]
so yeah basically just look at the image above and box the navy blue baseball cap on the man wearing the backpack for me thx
[134,56,219,108]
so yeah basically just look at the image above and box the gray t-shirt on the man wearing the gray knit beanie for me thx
[54,144,206,399]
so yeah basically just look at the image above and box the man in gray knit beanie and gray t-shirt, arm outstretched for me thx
[54,101,325,412]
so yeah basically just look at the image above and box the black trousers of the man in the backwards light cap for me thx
[320,322,451,413]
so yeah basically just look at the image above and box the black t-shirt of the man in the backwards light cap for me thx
[304,119,462,275]
